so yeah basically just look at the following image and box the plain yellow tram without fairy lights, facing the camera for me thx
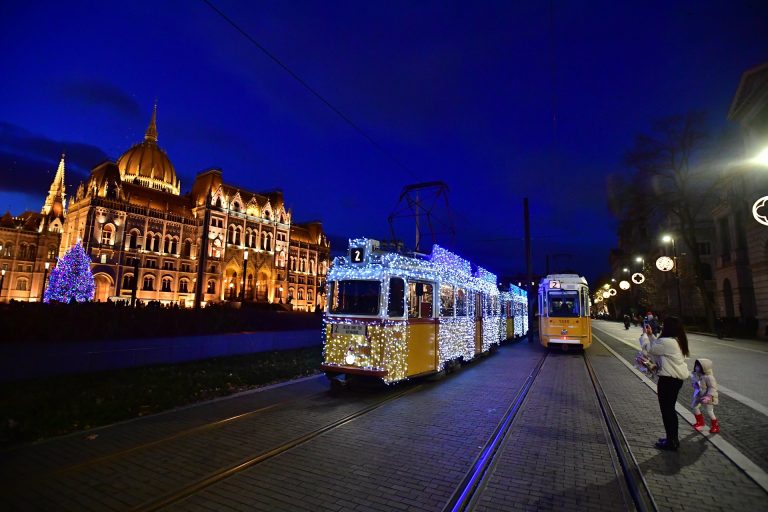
[538,274,592,350]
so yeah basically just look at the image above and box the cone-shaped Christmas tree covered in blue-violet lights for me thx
[43,240,96,304]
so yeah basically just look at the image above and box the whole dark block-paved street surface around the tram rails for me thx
[0,330,768,511]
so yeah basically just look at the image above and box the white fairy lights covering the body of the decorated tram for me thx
[324,238,527,383]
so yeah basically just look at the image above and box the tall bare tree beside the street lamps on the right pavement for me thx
[627,112,717,327]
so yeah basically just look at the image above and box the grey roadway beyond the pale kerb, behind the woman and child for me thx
[594,322,768,476]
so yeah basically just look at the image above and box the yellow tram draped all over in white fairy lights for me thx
[321,238,528,384]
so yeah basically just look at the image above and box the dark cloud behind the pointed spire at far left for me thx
[0,121,108,196]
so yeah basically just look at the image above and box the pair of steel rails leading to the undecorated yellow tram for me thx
[443,351,658,512]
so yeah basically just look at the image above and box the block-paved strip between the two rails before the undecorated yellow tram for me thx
[476,351,627,511]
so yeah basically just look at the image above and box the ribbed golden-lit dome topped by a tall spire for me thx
[117,106,181,195]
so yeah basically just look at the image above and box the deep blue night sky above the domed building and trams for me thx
[0,0,768,284]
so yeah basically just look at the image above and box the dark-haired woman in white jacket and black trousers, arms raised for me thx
[640,316,689,451]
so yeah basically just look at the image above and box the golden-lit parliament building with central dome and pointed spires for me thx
[0,109,330,311]
